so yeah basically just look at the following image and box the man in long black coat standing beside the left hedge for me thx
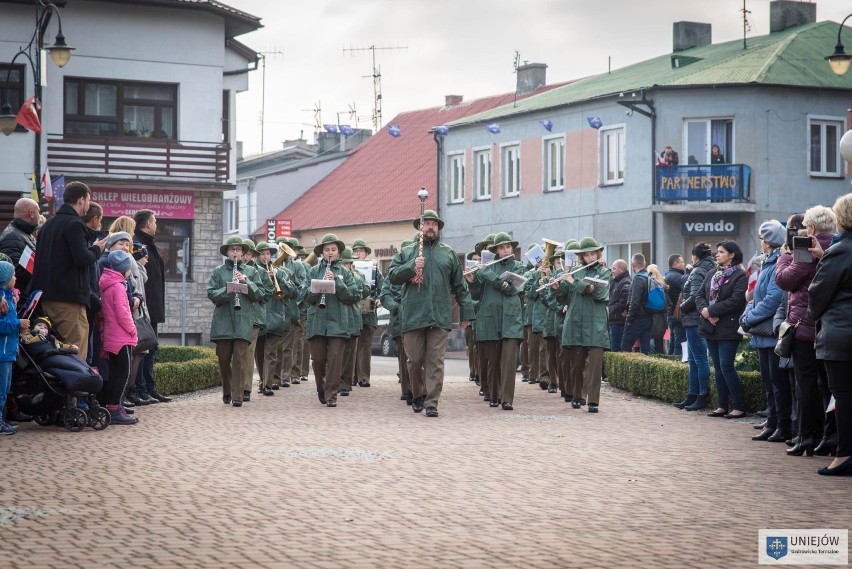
[133,209,171,403]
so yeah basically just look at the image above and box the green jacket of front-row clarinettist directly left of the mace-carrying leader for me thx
[302,259,361,339]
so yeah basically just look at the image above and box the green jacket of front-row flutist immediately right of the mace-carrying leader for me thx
[471,259,524,342]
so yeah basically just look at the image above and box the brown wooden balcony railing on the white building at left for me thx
[47,134,230,182]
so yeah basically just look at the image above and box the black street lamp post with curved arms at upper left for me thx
[0,0,74,207]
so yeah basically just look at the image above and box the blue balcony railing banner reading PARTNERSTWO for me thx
[656,164,751,203]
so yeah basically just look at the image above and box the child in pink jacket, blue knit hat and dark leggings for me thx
[100,250,139,425]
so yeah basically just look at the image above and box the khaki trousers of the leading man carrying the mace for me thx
[403,328,449,408]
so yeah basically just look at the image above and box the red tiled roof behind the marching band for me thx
[266,85,556,232]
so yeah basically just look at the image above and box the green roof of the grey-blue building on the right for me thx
[450,22,852,125]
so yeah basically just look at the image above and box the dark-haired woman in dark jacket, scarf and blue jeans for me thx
[695,241,748,419]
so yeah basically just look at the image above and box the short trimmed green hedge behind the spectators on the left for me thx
[154,346,222,395]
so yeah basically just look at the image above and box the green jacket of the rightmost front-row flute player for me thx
[556,264,612,350]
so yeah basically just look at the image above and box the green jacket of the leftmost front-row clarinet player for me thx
[207,261,261,342]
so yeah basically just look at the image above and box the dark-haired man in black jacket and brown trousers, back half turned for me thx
[32,182,106,360]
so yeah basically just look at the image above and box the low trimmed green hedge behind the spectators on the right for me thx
[604,352,766,413]
